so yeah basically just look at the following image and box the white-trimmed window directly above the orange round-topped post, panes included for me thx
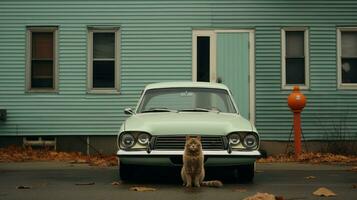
[281,28,309,89]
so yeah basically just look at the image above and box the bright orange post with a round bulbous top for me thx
[288,86,306,158]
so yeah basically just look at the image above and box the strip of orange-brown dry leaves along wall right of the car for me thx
[258,152,357,163]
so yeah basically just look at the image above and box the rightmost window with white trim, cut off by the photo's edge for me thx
[337,28,357,88]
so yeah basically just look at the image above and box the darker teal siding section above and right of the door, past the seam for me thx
[212,1,357,140]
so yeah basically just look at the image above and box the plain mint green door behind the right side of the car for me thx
[216,33,249,119]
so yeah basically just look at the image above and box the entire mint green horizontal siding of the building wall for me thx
[0,0,357,140]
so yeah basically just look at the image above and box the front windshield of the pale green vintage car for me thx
[137,88,237,113]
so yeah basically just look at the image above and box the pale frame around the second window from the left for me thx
[87,27,120,94]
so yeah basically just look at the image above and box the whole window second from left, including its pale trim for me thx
[88,28,119,93]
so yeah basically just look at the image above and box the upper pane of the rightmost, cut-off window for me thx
[341,31,357,57]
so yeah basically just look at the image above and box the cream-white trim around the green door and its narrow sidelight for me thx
[192,29,255,123]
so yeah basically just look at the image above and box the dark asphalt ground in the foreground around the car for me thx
[0,162,357,200]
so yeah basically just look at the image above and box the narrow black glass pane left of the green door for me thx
[197,37,210,82]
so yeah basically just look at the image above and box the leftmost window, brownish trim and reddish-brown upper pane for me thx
[26,27,58,92]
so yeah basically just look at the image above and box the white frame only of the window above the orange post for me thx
[281,27,310,90]
